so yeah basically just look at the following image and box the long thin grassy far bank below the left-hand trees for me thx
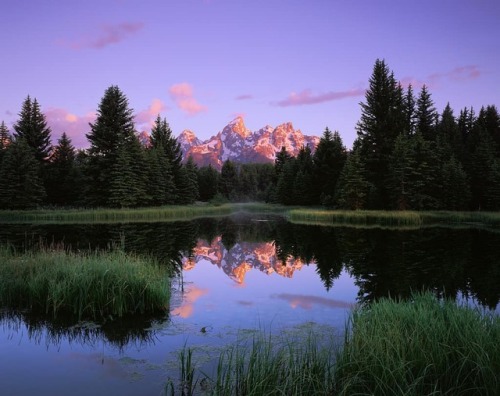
[0,203,284,224]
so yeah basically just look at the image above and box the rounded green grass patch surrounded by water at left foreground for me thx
[0,248,170,320]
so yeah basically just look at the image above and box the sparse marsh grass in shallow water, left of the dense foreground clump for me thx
[167,333,335,396]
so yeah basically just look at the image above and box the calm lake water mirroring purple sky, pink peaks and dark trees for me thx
[0,215,500,395]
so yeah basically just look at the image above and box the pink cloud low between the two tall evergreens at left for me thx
[44,108,96,148]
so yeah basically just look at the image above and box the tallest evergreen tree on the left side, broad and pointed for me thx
[85,86,145,207]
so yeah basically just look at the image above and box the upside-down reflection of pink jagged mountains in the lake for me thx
[183,236,305,284]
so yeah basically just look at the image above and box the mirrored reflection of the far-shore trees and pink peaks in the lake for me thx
[0,215,500,308]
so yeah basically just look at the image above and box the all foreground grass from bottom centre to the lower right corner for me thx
[167,294,500,396]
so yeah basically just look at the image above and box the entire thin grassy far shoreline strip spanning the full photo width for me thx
[0,202,500,228]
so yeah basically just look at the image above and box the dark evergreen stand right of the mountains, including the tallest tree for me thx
[275,60,500,210]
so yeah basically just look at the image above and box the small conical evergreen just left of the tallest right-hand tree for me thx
[337,148,371,210]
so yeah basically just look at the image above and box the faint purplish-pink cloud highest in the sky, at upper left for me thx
[60,22,144,50]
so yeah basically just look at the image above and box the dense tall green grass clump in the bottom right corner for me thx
[335,293,500,395]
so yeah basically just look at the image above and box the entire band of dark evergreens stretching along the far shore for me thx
[0,60,500,210]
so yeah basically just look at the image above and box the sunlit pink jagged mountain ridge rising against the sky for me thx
[177,117,319,170]
